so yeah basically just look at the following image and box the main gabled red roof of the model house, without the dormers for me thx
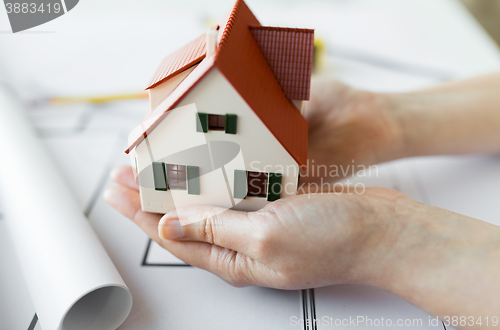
[125,0,309,165]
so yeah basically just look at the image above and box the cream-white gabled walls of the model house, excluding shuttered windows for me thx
[136,68,298,213]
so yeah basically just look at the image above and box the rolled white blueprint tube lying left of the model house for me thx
[0,80,132,330]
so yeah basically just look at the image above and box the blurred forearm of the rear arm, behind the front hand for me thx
[387,73,500,157]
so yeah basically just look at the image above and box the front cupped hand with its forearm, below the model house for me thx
[105,167,500,329]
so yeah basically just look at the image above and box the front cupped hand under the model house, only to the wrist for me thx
[105,167,419,289]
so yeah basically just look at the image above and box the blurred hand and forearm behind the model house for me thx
[301,73,500,183]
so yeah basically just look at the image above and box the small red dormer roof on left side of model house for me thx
[146,34,206,89]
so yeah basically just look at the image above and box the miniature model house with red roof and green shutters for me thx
[126,0,314,213]
